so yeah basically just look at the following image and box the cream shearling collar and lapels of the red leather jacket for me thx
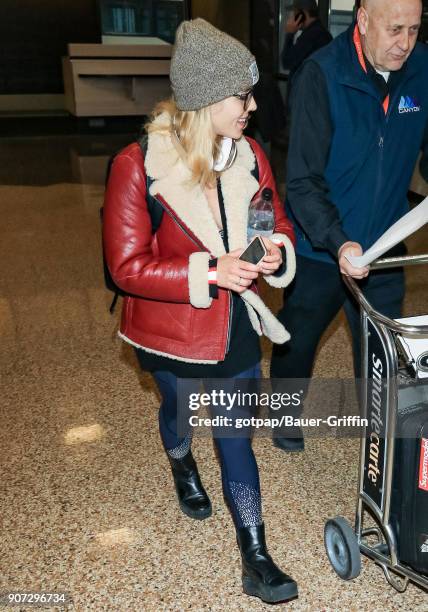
[145,114,259,257]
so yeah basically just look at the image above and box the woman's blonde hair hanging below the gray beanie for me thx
[145,98,221,188]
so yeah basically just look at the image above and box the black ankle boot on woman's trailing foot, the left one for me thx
[168,451,212,520]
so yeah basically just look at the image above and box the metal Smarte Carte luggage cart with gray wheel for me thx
[324,255,428,592]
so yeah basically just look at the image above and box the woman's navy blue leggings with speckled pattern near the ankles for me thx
[153,364,262,529]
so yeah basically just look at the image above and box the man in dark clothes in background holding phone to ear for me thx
[281,0,332,81]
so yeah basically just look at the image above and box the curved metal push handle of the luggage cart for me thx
[342,255,428,336]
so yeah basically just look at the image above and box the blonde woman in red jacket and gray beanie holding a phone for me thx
[104,19,297,602]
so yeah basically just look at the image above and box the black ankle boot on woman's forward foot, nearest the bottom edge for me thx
[237,523,297,603]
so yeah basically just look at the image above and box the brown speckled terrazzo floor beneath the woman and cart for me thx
[0,136,428,612]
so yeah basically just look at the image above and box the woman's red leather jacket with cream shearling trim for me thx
[103,122,295,363]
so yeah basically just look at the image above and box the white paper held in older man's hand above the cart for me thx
[346,197,428,268]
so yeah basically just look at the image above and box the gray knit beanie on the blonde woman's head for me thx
[170,19,259,111]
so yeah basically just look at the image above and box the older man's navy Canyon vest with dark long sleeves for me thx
[287,26,428,262]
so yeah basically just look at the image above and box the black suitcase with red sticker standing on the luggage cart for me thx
[391,402,428,574]
